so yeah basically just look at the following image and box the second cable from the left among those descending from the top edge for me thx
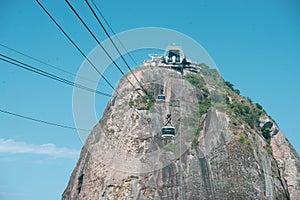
[66,0,136,93]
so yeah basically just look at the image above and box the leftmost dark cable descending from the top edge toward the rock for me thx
[35,0,121,96]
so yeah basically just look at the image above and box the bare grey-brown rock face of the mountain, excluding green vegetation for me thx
[62,68,300,199]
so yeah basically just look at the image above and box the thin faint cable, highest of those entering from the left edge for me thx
[0,44,106,85]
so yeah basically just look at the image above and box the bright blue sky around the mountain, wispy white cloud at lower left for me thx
[0,0,300,200]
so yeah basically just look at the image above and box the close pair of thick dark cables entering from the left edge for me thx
[0,54,112,97]
